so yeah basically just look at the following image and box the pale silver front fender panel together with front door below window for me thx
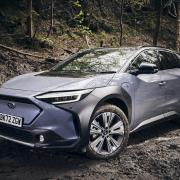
[110,71,165,131]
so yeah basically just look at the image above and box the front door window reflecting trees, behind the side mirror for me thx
[130,50,159,70]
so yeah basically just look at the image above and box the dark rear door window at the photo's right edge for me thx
[159,51,180,70]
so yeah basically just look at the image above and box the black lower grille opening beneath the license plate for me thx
[0,124,34,143]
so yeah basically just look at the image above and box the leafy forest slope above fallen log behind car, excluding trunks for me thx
[0,0,176,54]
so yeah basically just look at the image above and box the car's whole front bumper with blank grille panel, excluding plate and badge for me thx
[0,95,81,149]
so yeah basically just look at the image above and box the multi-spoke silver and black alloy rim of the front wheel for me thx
[89,112,125,155]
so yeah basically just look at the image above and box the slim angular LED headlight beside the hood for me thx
[36,89,93,105]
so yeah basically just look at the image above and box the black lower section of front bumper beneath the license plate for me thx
[0,124,78,149]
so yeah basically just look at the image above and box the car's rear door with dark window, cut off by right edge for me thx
[158,50,180,117]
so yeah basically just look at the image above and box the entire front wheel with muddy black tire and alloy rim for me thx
[86,104,129,160]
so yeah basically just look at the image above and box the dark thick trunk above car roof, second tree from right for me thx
[153,0,162,46]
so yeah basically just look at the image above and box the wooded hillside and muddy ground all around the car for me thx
[0,0,180,180]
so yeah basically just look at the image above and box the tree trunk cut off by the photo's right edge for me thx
[176,0,180,52]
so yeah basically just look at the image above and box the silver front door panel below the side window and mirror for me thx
[133,72,165,130]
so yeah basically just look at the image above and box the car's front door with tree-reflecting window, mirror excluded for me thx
[130,50,165,128]
